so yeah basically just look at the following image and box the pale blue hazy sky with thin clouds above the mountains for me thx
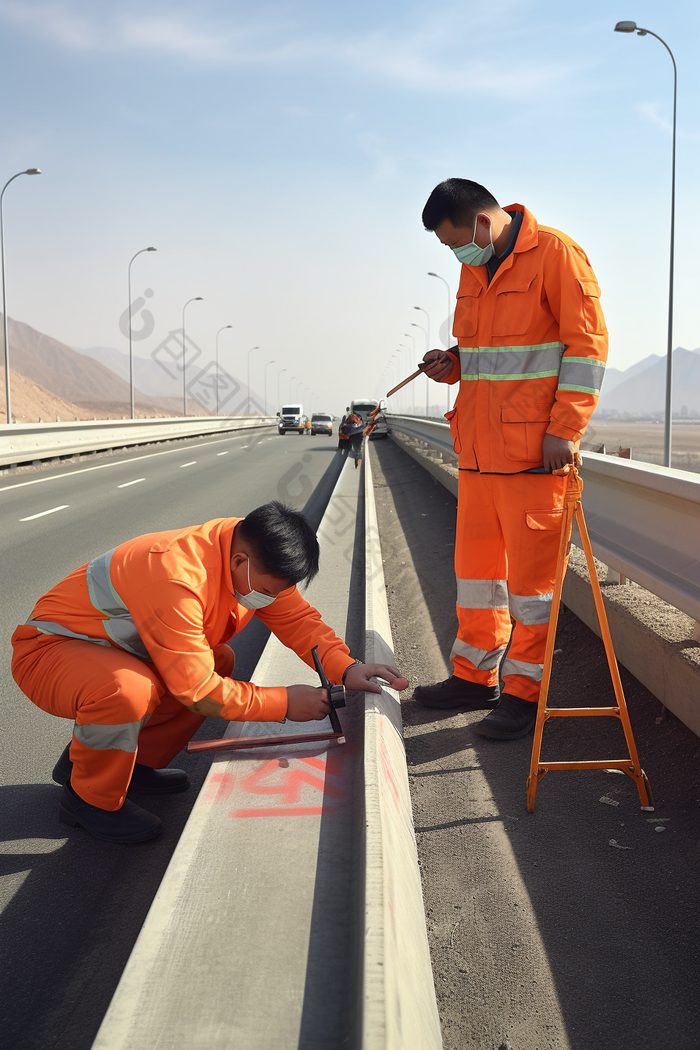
[0,0,700,412]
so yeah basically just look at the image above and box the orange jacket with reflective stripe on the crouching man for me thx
[22,518,353,721]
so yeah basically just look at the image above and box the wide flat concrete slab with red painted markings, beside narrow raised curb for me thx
[92,462,359,1050]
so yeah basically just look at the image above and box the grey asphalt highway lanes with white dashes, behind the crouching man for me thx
[0,432,339,1050]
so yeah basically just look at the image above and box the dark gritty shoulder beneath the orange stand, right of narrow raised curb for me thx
[372,441,700,1050]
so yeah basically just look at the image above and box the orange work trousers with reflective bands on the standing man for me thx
[450,470,567,701]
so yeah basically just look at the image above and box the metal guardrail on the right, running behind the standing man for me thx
[388,416,700,621]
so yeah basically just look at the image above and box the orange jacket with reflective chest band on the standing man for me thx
[443,204,608,474]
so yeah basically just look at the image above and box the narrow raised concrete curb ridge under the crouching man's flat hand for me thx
[361,442,443,1050]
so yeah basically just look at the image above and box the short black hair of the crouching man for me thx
[238,500,319,584]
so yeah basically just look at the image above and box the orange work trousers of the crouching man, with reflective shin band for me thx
[13,626,234,810]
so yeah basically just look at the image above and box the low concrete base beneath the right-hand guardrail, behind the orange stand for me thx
[391,433,700,736]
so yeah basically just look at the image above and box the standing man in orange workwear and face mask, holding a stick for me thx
[415,179,608,740]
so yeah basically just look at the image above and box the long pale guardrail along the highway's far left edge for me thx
[0,416,277,469]
